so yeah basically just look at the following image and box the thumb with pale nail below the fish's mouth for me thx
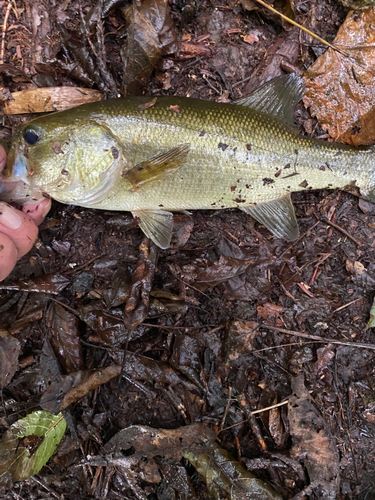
[0,201,38,261]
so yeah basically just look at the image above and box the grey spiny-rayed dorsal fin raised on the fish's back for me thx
[233,73,305,125]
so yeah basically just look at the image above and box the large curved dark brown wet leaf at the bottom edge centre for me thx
[98,424,281,500]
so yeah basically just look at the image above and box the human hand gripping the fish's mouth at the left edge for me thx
[0,145,51,281]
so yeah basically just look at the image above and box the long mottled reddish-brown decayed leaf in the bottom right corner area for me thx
[288,375,340,498]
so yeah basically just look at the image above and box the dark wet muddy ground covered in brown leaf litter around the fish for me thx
[0,0,375,499]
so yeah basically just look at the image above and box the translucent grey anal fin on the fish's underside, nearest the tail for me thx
[241,194,299,241]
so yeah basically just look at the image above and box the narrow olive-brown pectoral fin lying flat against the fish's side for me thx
[122,144,190,191]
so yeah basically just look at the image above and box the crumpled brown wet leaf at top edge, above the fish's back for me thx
[122,0,177,95]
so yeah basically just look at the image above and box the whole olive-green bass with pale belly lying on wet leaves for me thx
[1,74,375,249]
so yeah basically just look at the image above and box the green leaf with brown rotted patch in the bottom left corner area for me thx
[0,411,66,484]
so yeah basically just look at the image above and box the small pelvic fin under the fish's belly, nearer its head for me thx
[132,210,173,248]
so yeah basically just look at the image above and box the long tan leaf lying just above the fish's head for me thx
[4,87,103,115]
